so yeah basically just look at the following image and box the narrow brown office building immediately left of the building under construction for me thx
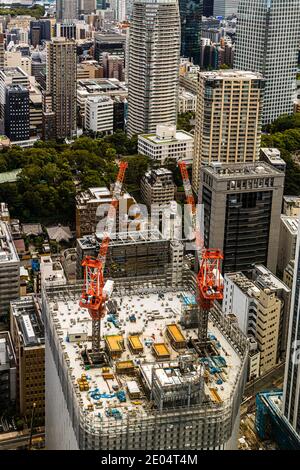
[10,295,45,424]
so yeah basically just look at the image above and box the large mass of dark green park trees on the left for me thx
[0,131,148,226]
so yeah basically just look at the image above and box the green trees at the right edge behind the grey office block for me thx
[261,113,300,195]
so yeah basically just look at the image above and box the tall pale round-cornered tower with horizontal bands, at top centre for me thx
[127,0,180,136]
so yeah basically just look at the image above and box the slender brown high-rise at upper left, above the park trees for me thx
[47,38,76,139]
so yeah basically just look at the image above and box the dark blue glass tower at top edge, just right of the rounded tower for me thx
[179,0,203,65]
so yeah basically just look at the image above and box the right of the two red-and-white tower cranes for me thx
[178,162,224,342]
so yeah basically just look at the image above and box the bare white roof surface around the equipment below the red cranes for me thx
[46,285,241,420]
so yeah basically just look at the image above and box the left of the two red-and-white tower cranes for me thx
[80,162,128,352]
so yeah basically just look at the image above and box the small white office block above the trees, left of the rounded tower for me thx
[84,96,114,134]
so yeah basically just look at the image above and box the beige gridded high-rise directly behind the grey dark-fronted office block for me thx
[193,70,264,191]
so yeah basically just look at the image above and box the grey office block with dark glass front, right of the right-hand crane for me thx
[199,162,284,273]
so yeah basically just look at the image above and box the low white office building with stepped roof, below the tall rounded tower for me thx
[138,124,194,165]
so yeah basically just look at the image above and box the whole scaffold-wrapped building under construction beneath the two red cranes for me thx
[42,270,248,450]
